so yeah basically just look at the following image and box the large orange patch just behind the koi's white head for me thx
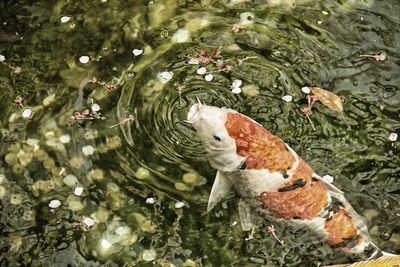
[225,113,295,172]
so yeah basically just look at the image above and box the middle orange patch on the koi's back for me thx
[259,181,328,220]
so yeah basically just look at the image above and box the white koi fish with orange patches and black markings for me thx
[187,102,400,261]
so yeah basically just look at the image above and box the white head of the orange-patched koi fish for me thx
[187,103,244,171]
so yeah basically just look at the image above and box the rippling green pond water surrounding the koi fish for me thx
[0,0,400,267]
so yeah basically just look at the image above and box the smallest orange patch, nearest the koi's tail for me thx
[324,208,357,246]
